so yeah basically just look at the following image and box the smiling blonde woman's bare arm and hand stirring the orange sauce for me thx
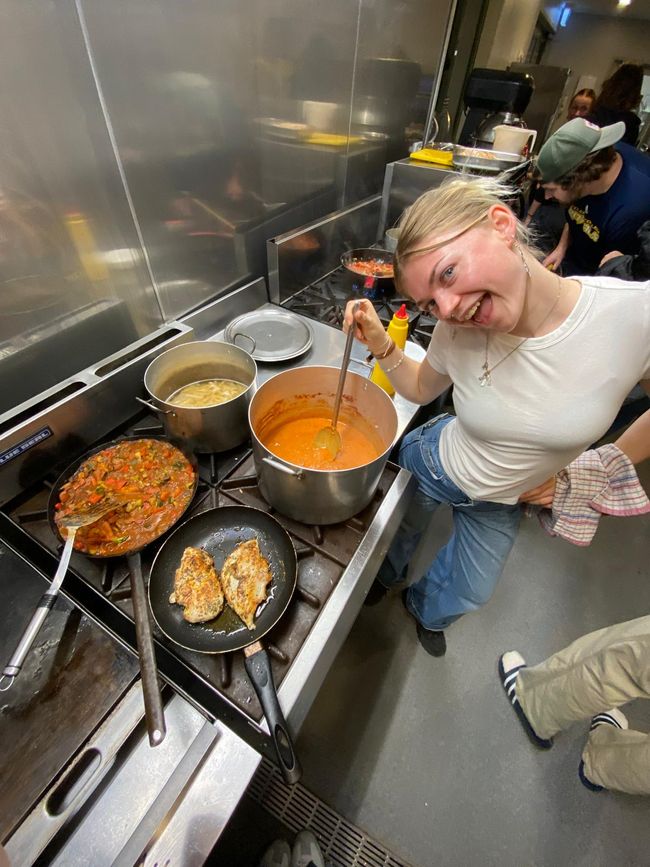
[343,299,451,404]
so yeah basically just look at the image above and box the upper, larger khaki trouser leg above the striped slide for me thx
[516,616,650,738]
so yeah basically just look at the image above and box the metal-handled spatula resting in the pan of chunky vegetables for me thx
[0,498,124,692]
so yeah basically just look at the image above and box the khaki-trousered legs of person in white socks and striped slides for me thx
[499,612,650,795]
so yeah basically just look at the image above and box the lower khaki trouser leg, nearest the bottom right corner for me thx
[582,725,650,795]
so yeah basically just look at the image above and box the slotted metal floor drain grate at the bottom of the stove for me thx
[248,759,411,867]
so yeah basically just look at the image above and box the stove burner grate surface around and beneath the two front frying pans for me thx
[0,416,399,761]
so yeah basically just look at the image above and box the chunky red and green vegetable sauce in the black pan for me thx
[54,439,195,557]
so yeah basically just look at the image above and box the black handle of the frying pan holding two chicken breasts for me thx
[244,641,302,786]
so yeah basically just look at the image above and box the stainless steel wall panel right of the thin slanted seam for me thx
[79,0,357,317]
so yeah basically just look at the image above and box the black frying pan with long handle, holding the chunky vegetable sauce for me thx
[47,435,199,747]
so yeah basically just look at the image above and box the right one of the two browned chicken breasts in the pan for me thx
[221,539,273,629]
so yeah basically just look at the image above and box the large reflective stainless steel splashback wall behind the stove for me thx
[0,0,451,413]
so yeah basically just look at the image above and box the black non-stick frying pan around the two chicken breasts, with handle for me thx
[149,506,302,783]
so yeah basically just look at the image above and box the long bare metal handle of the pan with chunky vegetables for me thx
[127,554,167,747]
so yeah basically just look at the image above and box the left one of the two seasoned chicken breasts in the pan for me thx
[169,548,223,623]
